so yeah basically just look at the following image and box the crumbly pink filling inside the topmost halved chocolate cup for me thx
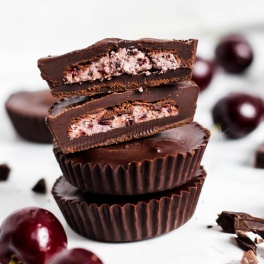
[64,48,180,84]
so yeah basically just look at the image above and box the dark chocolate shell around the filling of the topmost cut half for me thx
[38,38,198,97]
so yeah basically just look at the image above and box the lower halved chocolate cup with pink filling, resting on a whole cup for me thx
[46,81,198,154]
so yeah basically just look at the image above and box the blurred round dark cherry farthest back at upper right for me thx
[215,35,253,73]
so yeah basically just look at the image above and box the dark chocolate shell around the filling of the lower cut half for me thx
[46,81,199,154]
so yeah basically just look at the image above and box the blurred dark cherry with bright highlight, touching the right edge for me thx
[212,93,264,138]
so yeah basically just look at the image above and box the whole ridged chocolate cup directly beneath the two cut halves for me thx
[53,122,210,195]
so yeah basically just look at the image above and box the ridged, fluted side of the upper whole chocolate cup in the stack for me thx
[53,123,210,195]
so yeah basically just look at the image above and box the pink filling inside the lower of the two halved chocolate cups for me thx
[68,103,179,139]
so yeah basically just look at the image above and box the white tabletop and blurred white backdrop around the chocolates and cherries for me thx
[0,0,264,264]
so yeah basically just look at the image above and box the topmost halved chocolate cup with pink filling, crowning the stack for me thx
[38,38,198,97]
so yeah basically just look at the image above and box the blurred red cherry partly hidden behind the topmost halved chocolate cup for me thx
[192,56,214,92]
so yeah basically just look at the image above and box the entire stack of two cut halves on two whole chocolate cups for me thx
[38,39,210,242]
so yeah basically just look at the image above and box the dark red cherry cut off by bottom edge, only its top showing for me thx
[46,248,103,264]
